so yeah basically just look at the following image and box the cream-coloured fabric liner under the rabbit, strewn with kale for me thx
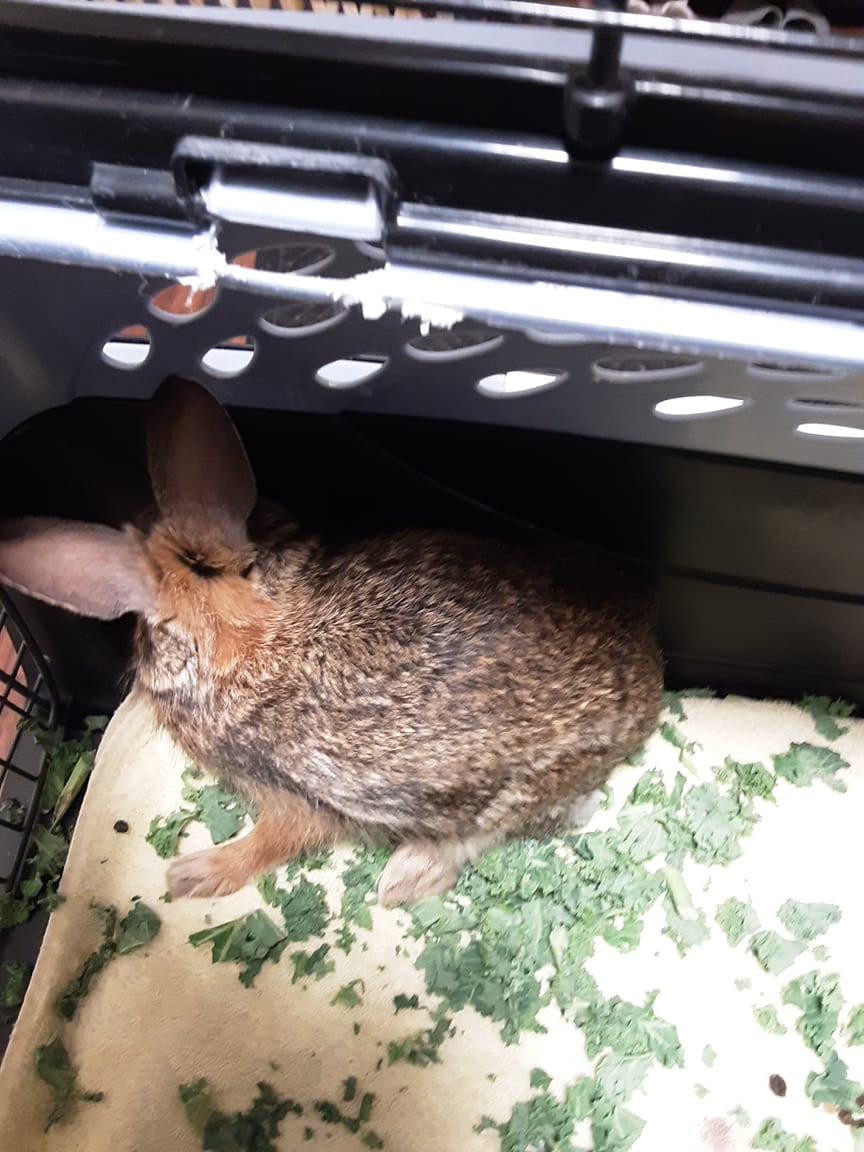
[0,686,864,1152]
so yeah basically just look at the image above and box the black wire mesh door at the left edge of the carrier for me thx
[0,592,58,893]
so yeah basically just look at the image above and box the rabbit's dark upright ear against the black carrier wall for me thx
[147,376,257,539]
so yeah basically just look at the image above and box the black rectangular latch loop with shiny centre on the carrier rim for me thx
[172,136,396,243]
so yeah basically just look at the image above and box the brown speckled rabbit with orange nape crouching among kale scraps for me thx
[0,378,662,904]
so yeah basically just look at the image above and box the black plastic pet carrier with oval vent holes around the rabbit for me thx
[0,0,864,866]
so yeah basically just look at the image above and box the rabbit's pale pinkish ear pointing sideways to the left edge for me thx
[0,517,156,620]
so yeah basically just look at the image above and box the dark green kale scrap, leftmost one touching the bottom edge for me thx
[177,1079,303,1152]
